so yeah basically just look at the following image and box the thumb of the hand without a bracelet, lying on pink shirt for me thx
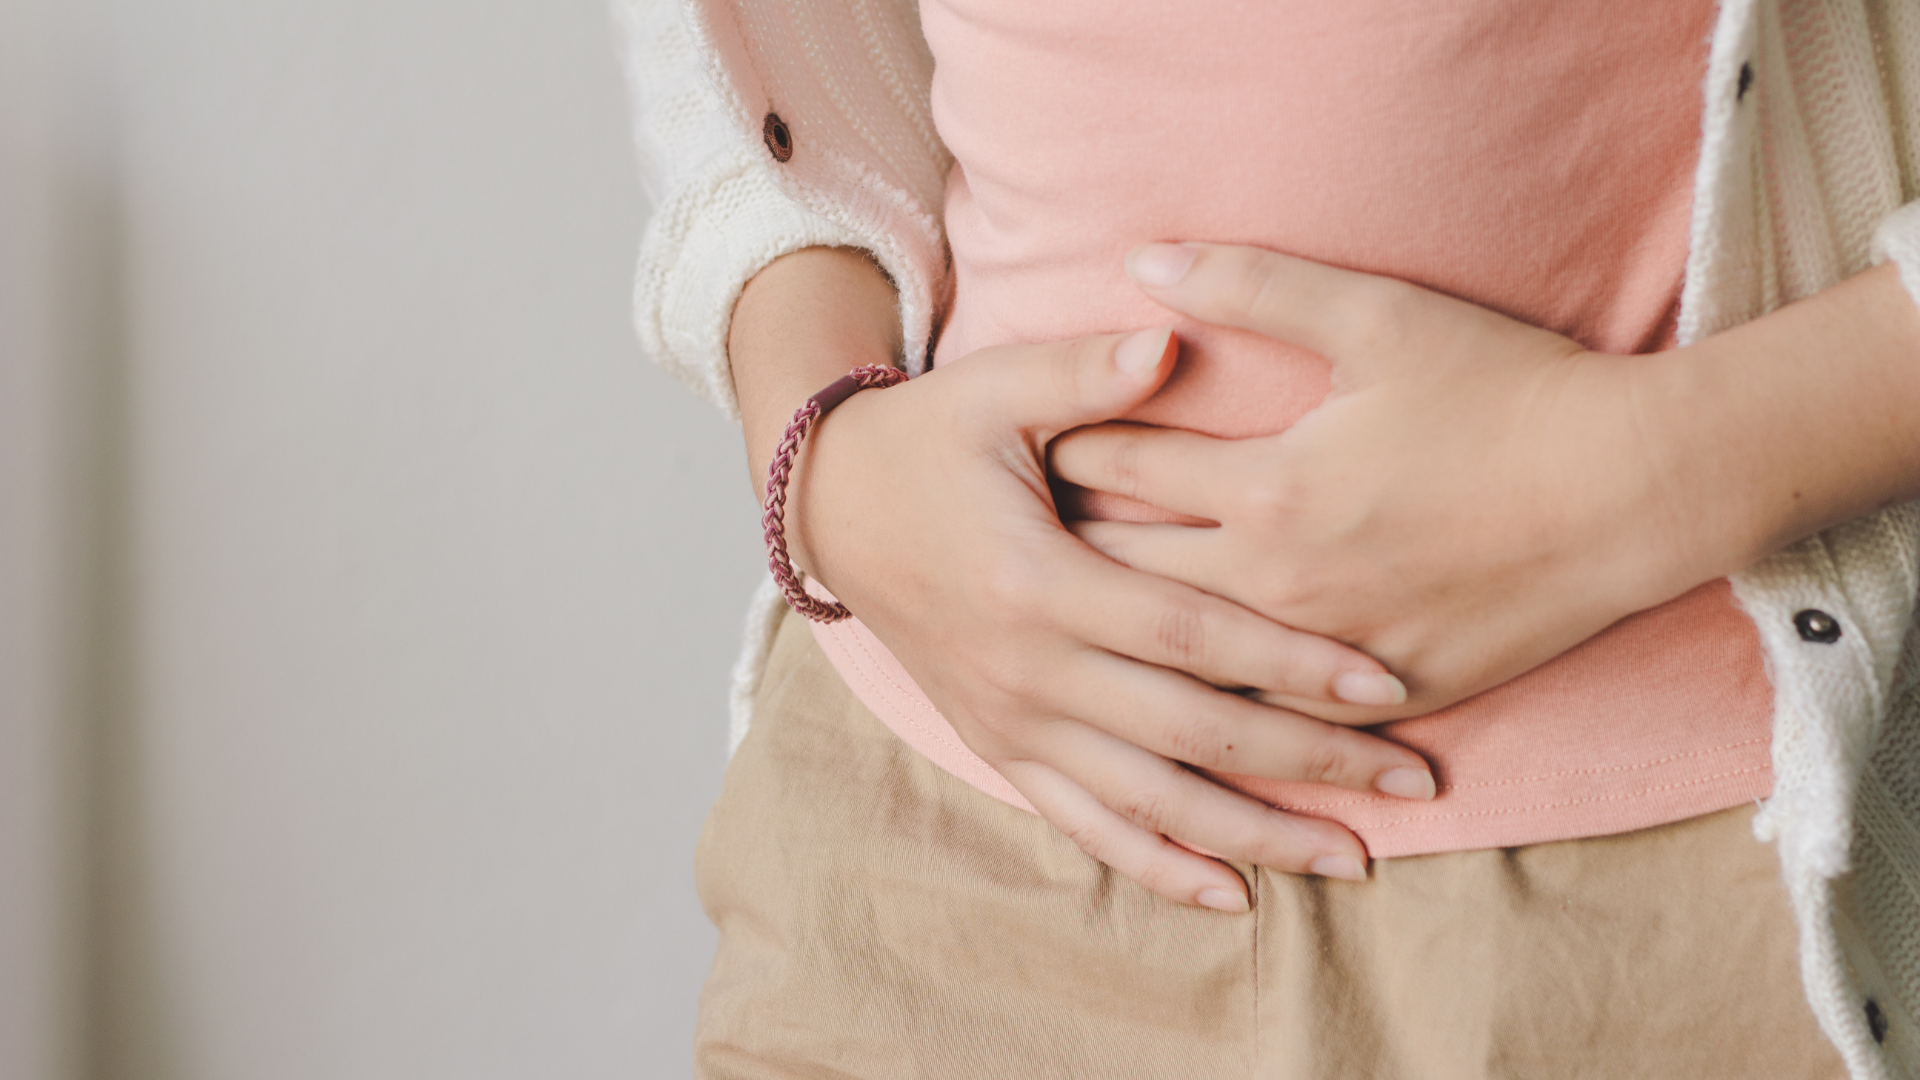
[1127,244,1440,363]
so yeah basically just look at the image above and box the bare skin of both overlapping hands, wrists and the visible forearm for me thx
[730,246,1920,911]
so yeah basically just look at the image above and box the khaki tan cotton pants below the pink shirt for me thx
[695,615,1845,1080]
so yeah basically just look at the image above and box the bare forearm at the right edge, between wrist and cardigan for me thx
[1645,265,1920,575]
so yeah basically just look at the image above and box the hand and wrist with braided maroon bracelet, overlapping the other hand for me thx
[730,248,1434,911]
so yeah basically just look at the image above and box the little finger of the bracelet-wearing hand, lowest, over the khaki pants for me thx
[1000,761,1252,913]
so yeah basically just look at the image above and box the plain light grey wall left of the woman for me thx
[0,0,760,1080]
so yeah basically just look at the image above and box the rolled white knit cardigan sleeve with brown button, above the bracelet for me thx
[612,0,948,419]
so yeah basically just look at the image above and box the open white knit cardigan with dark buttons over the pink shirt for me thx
[614,0,1920,1080]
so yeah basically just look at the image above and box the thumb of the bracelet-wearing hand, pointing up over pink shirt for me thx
[954,327,1179,442]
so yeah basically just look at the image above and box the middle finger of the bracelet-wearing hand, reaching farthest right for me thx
[1052,651,1434,799]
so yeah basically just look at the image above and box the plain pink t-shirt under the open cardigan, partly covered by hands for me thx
[816,0,1772,857]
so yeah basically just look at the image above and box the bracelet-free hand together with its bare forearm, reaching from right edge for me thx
[1052,244,1920,715]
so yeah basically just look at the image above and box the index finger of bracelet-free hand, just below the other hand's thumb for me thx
[1046,423,1244,521]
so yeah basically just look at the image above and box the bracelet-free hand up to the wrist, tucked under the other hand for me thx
[1052,244,1751,721]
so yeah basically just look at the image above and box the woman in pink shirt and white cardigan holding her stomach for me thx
[632,4,1920,1076]
